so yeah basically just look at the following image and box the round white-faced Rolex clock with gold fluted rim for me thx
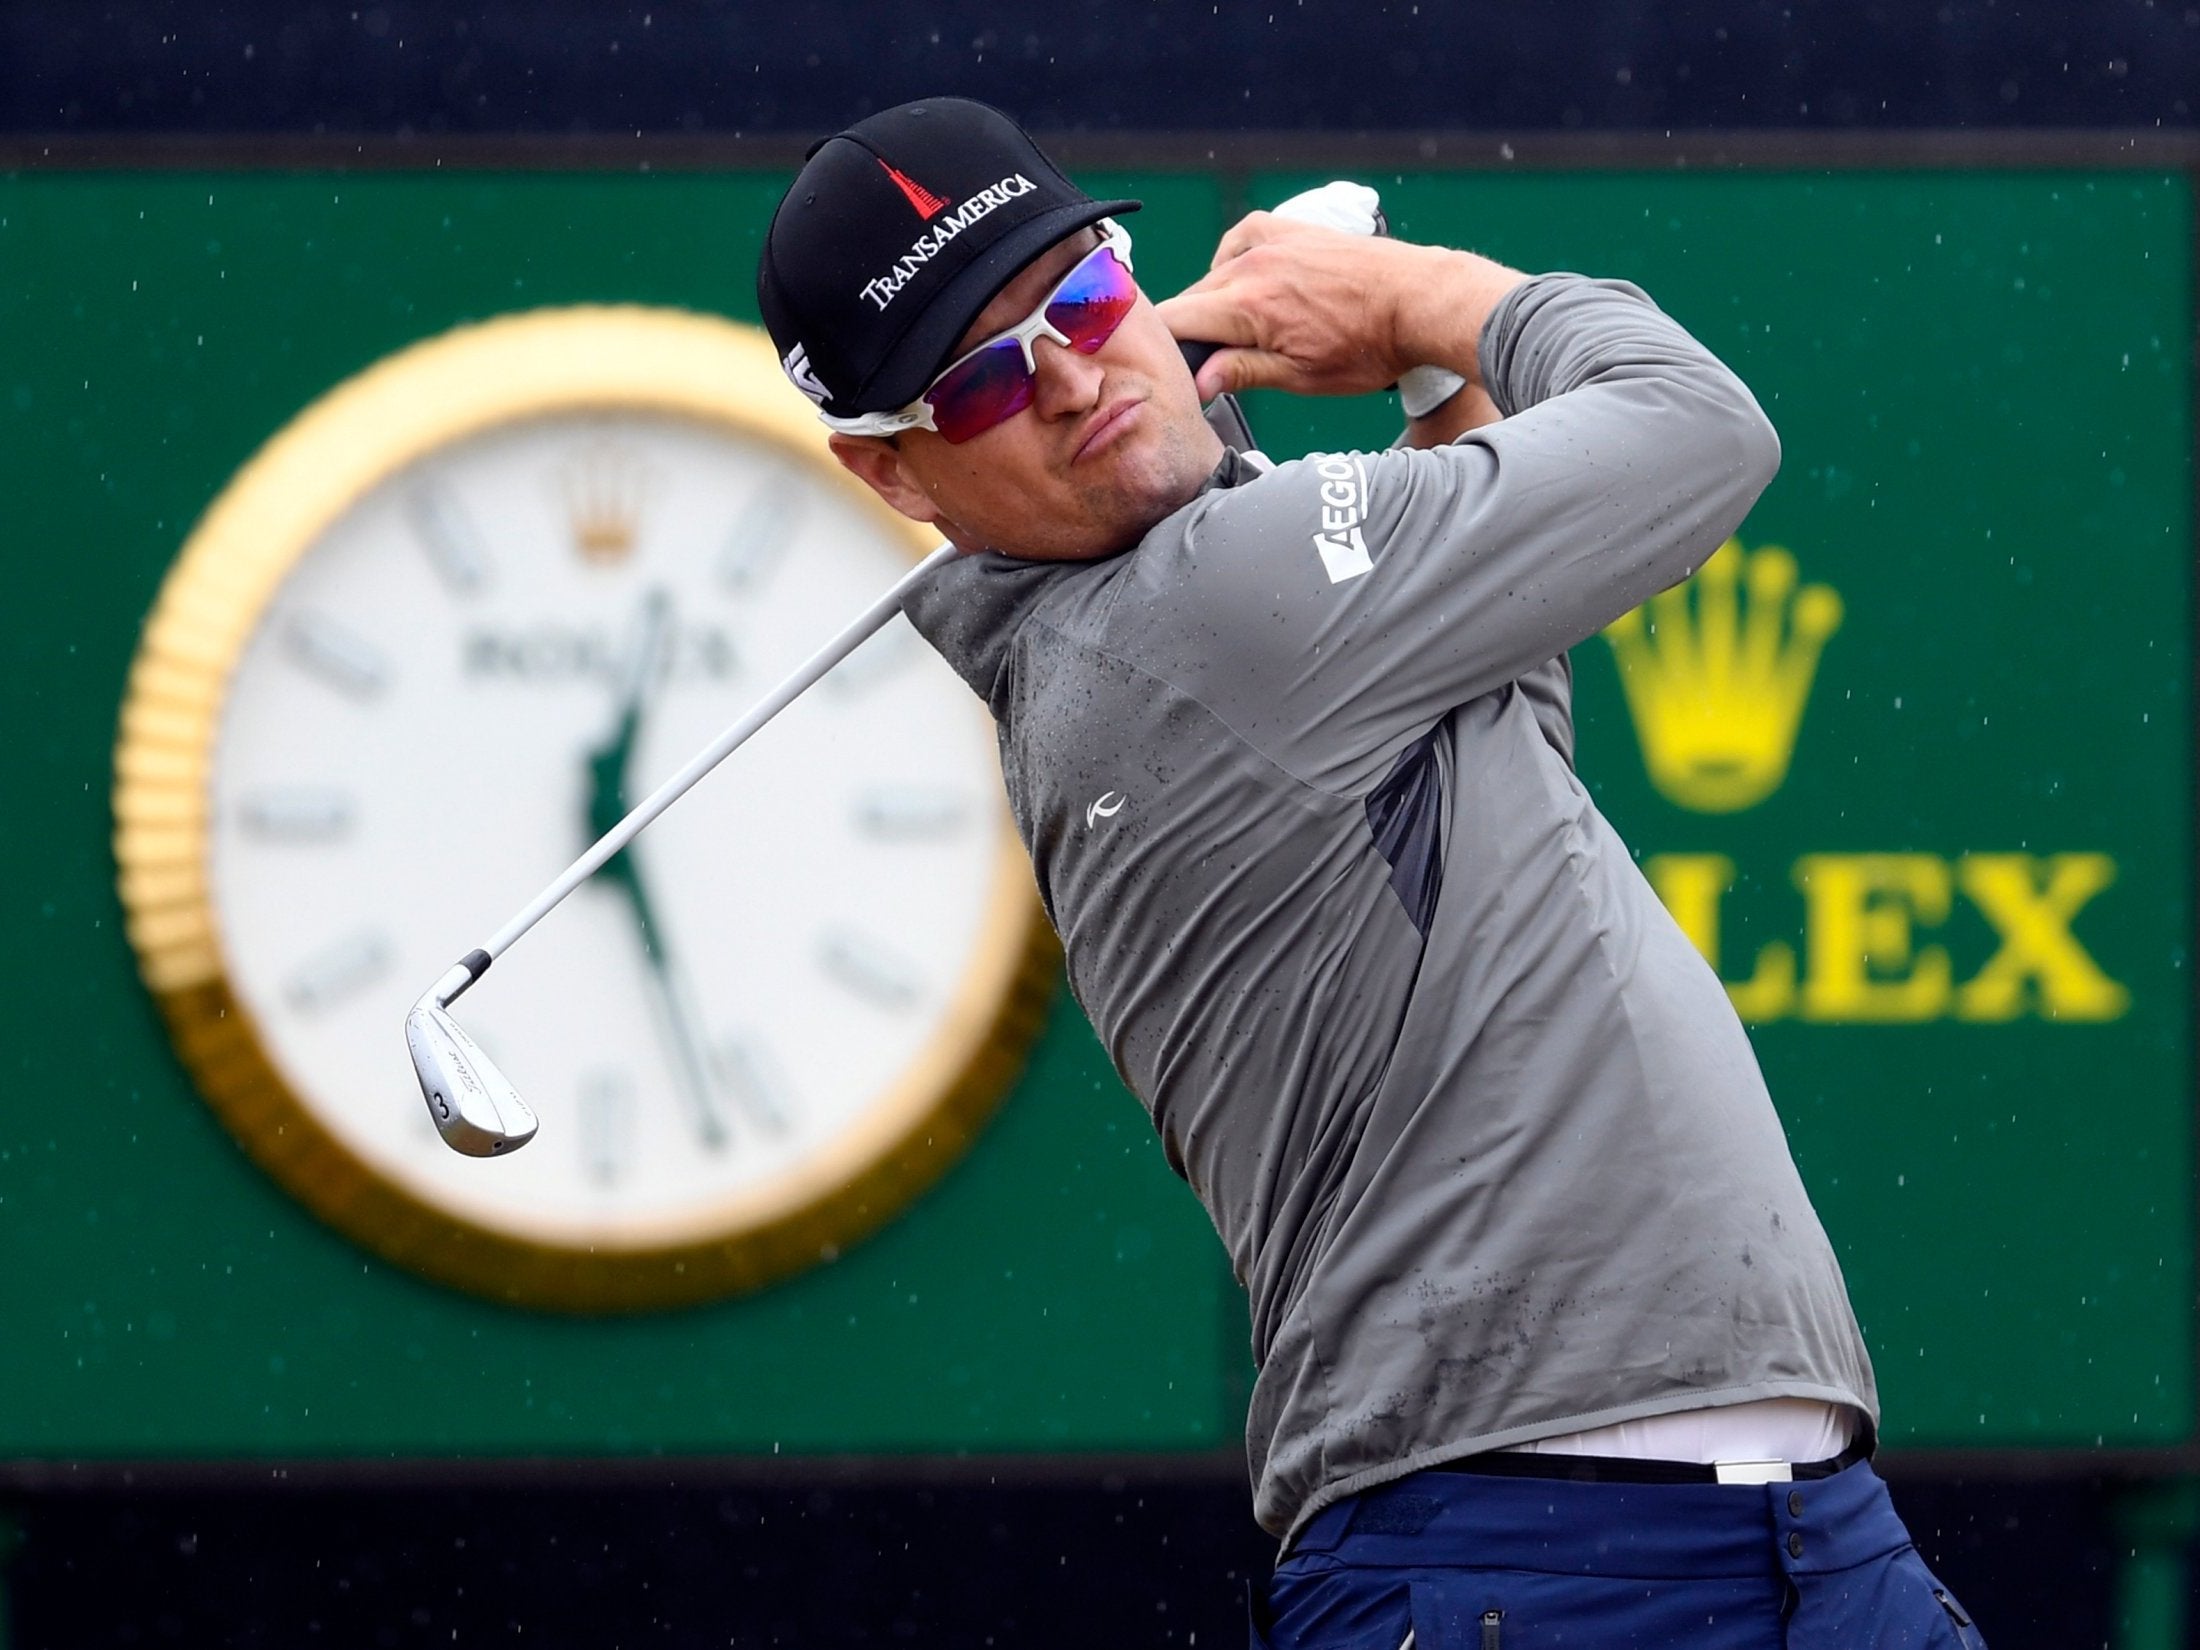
[114,308,1054,1311]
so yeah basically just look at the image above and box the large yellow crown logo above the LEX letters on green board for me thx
[1604,539,1841,814]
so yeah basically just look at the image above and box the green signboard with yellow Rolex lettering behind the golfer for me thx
[0,158,2193,1459]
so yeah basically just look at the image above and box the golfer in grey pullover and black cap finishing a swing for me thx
[757,99,1980,1650]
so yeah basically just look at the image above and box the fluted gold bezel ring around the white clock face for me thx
[114,306,1060,1313]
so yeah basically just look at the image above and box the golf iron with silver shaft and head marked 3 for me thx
[405,543,957,1157]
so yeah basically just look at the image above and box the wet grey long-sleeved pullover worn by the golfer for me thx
[909,275,1877,1536]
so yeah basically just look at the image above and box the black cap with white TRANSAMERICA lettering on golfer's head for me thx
[757,97,1140,418]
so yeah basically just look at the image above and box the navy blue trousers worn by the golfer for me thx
[1252,1461,1984,1650]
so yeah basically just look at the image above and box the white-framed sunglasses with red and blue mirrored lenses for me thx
[818,218,1137,442]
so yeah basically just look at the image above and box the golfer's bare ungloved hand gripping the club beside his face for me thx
[1157,211,1527,400]
